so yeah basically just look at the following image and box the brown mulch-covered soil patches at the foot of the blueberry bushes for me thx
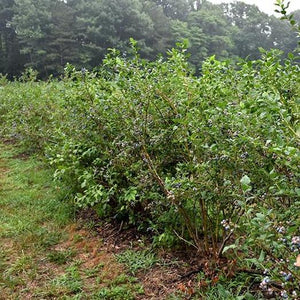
[78,210,235,300]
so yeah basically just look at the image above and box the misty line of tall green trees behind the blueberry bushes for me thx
[0,0,300,77]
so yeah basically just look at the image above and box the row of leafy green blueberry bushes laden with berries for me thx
[0,40,300,298]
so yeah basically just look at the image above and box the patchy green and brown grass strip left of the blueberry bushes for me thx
[0,144,143,300]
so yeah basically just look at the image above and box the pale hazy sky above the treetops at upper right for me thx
[209,0,300,15]
